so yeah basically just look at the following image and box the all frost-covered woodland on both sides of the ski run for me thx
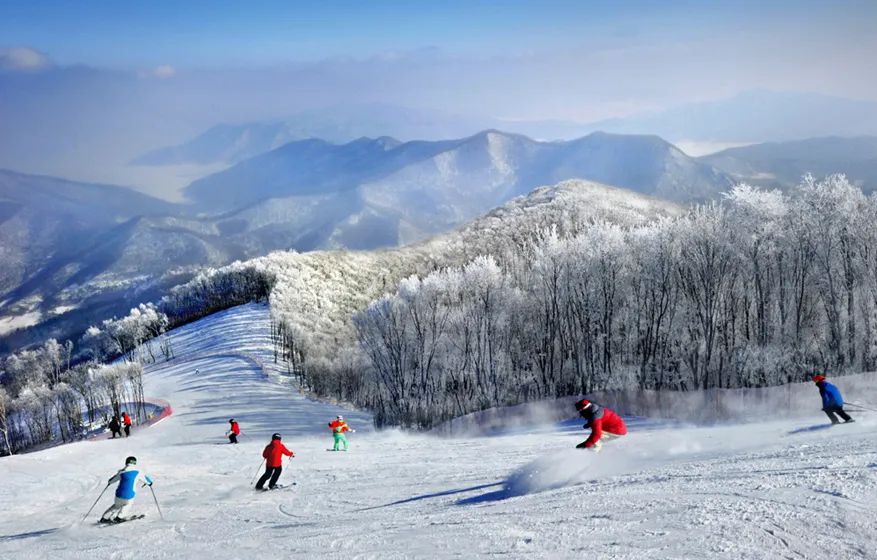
[3,176,877,442]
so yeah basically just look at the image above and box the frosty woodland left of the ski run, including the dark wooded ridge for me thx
[0,263,271,454]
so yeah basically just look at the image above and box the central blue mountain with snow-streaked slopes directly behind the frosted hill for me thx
[185,130,732,244]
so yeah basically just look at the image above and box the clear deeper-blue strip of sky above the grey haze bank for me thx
[0,0,877,68]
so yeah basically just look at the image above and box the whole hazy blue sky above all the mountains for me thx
[0,0,877,192]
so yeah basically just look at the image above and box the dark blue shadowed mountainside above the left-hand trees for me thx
[0,171,245,350]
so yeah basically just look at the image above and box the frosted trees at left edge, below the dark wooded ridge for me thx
[0,304,173,454]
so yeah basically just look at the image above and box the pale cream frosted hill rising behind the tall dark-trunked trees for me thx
[246,180,685,378]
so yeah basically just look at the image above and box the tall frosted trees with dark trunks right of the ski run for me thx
[272,176,877,427]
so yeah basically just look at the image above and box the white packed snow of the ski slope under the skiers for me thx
[0,305,877,560]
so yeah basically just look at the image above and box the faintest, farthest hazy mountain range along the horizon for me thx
[132,90,877,165]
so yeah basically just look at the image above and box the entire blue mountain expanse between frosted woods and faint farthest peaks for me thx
[6,130,877,353]
